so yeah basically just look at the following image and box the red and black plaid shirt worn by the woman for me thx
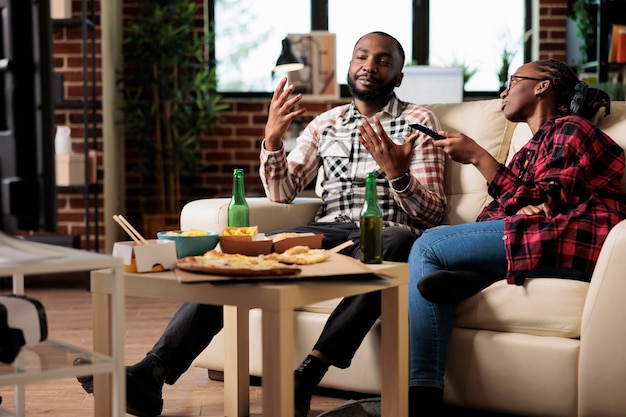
[478,116,626,285]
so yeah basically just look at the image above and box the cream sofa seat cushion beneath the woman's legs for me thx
[455,278,589,338]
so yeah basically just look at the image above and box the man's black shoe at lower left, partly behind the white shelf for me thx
[74,357,166,417]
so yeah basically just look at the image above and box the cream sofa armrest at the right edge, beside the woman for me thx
[578,220,626,416]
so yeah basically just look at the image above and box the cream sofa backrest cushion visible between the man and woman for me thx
[424,99,515,224]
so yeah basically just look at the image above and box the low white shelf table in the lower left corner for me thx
[0,242,126,417]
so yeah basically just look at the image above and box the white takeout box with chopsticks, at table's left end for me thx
[113,239,178,272]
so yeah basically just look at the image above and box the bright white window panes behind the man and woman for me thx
[208,0,531,94]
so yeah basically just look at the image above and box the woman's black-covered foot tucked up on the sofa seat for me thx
[417,271,499,303]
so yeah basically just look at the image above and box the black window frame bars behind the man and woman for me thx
[206,0,533,98]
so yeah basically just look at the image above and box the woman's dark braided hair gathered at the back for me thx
[534,59,611,119]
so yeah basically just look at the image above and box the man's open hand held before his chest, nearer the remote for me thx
[359,117,418,178]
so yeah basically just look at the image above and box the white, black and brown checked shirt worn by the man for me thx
[259,96,446,234]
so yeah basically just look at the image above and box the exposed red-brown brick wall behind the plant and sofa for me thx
[53,0,567,248]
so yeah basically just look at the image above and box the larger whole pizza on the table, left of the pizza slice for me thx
[176,250,301,276]
